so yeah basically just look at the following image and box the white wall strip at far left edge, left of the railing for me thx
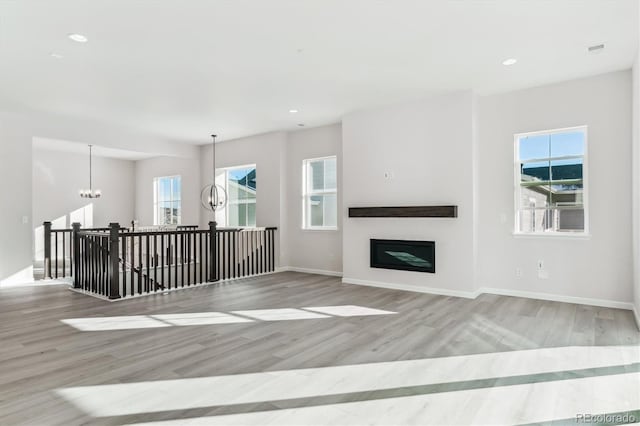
[0,114,32,285]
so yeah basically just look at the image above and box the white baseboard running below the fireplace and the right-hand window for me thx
[342,277,640,312]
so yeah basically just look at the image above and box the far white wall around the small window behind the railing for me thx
[135,157,201,226]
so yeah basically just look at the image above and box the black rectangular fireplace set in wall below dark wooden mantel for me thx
[371,239,436,273]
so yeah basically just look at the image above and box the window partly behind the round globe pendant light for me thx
[216,164,256,227]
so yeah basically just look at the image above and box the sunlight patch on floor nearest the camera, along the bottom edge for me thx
[126,373,640,426]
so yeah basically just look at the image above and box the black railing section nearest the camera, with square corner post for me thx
[66,222,276,299]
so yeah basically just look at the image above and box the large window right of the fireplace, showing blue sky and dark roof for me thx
[515,127,588,234]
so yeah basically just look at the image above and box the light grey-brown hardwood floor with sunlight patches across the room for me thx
[0,272,640,425]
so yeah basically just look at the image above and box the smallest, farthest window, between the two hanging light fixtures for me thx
[153,176,182,225]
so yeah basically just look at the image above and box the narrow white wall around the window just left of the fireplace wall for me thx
[283,124,342,275]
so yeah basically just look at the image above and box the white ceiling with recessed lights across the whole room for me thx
[0,0,638,144]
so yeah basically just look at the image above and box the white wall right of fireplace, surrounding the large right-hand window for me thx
[478,71,632,303]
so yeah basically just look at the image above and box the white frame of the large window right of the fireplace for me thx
[513,125,591,238]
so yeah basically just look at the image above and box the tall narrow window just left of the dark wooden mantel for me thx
[302,156,338,230]
